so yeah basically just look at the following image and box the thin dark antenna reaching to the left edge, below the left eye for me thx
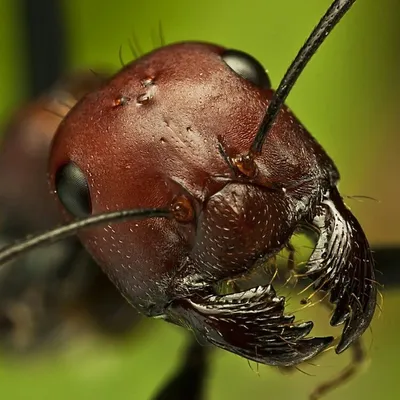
[0,208,172,265]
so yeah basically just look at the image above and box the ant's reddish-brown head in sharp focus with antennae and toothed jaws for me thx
[0,0,396,398]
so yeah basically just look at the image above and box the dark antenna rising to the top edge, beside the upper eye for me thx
[250,0,356,155]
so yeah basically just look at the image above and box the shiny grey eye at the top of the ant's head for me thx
[221,50,271,89]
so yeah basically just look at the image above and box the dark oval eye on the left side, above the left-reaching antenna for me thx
[55,162,92,218]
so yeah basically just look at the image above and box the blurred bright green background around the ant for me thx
[0,0,400,400]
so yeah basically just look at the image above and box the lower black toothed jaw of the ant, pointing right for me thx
[166,285,334,366]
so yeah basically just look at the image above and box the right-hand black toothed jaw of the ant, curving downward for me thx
[304,188,378,354]
